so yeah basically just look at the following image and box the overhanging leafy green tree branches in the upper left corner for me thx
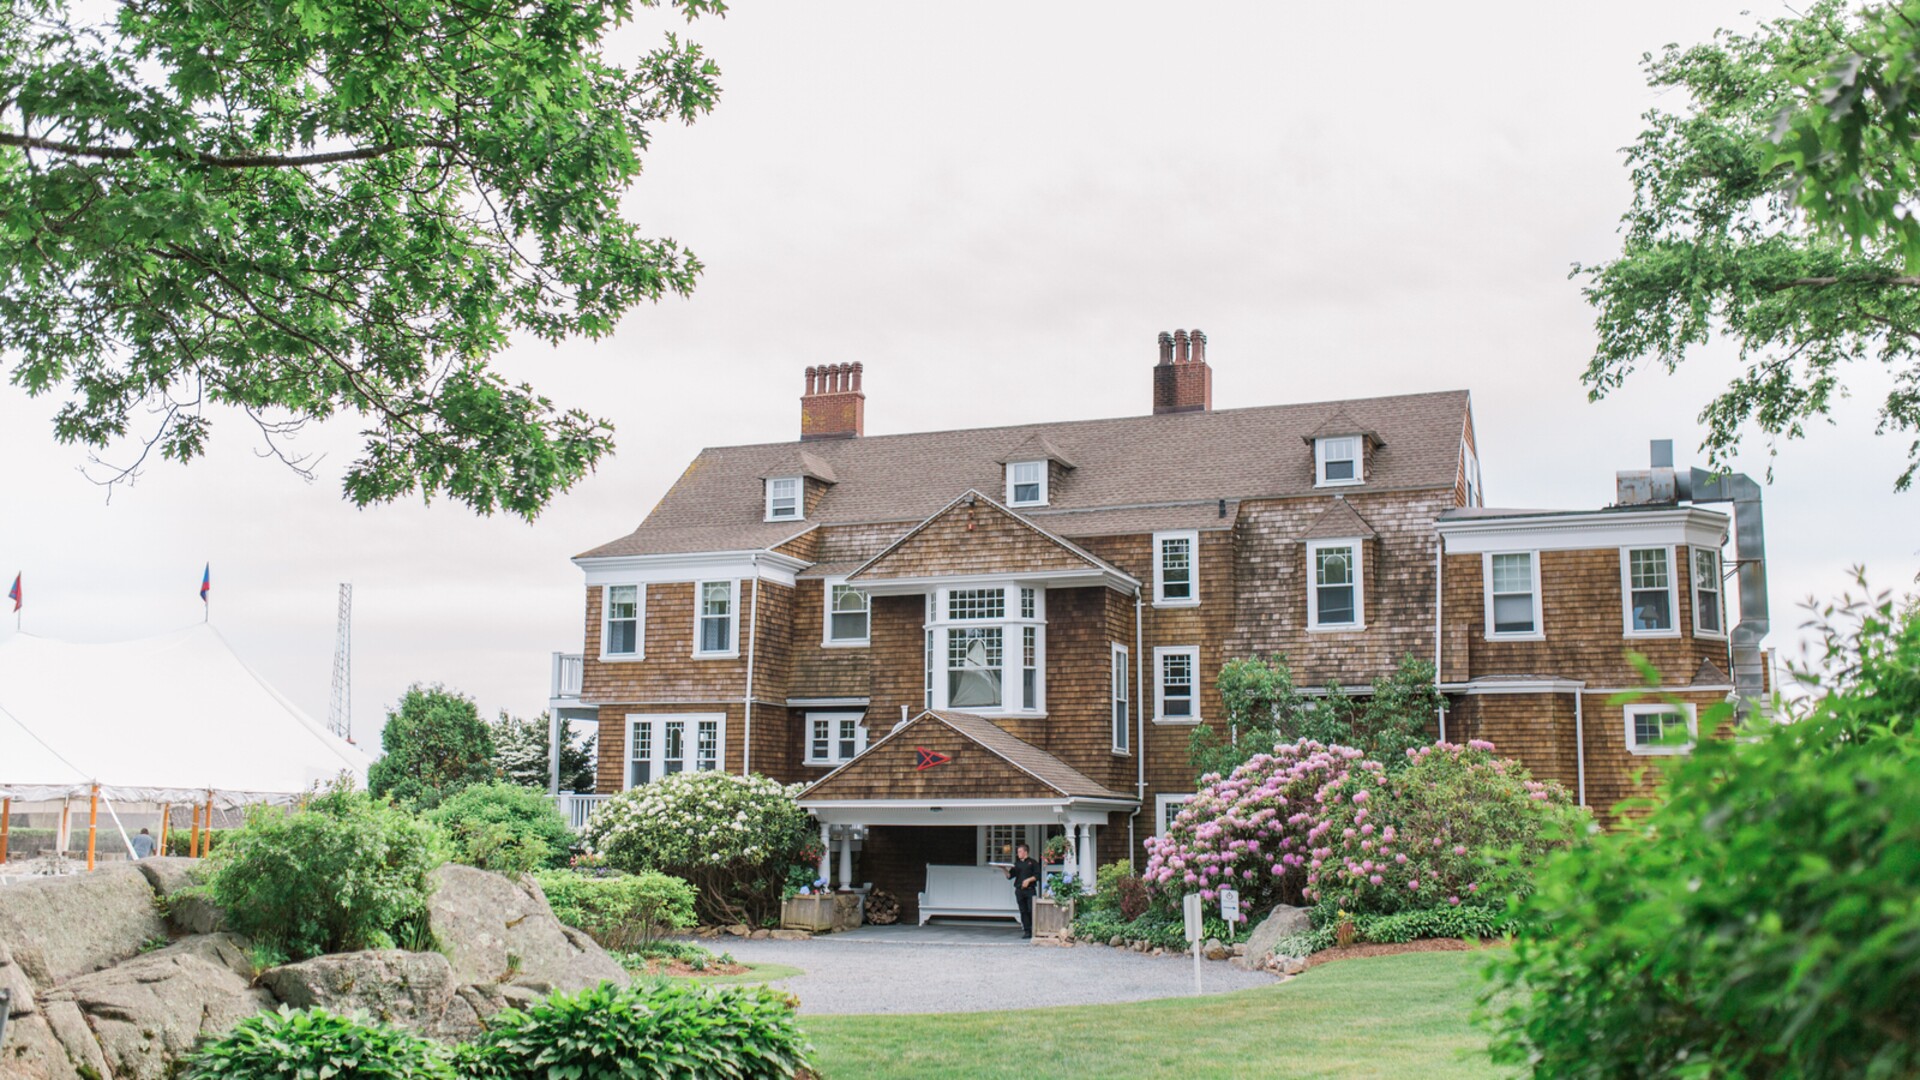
[0,0,726,517]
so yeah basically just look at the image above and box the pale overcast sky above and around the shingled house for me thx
[0,0,1920,740]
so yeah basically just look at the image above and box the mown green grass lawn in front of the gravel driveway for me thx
[801,953,1500,1080]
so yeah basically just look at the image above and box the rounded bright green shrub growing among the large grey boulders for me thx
[205,790,445,961]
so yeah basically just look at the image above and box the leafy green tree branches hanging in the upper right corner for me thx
[1574,0,1920,490]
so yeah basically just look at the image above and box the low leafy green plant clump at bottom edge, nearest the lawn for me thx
[480,984,814,1080]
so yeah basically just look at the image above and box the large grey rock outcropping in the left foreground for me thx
[0,859,626,1080]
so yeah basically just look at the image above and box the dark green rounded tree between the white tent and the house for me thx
[367,684,493,809]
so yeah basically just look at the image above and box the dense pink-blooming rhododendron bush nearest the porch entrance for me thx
[1142,740,1384,907]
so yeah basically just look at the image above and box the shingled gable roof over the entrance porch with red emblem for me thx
[801,709,1135,803]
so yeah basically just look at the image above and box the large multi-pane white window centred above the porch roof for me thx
[925,584,1046,713]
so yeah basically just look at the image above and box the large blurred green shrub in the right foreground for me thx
[1488,588,1920,1076]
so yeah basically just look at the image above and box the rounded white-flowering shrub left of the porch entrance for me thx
[584,771,818,926]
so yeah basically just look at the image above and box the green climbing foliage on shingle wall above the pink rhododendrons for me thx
[1187,653,1444,776]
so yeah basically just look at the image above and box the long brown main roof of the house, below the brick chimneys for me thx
[584,390,1469,557]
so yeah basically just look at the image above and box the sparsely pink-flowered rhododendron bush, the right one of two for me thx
[1306,740,1590,915]
